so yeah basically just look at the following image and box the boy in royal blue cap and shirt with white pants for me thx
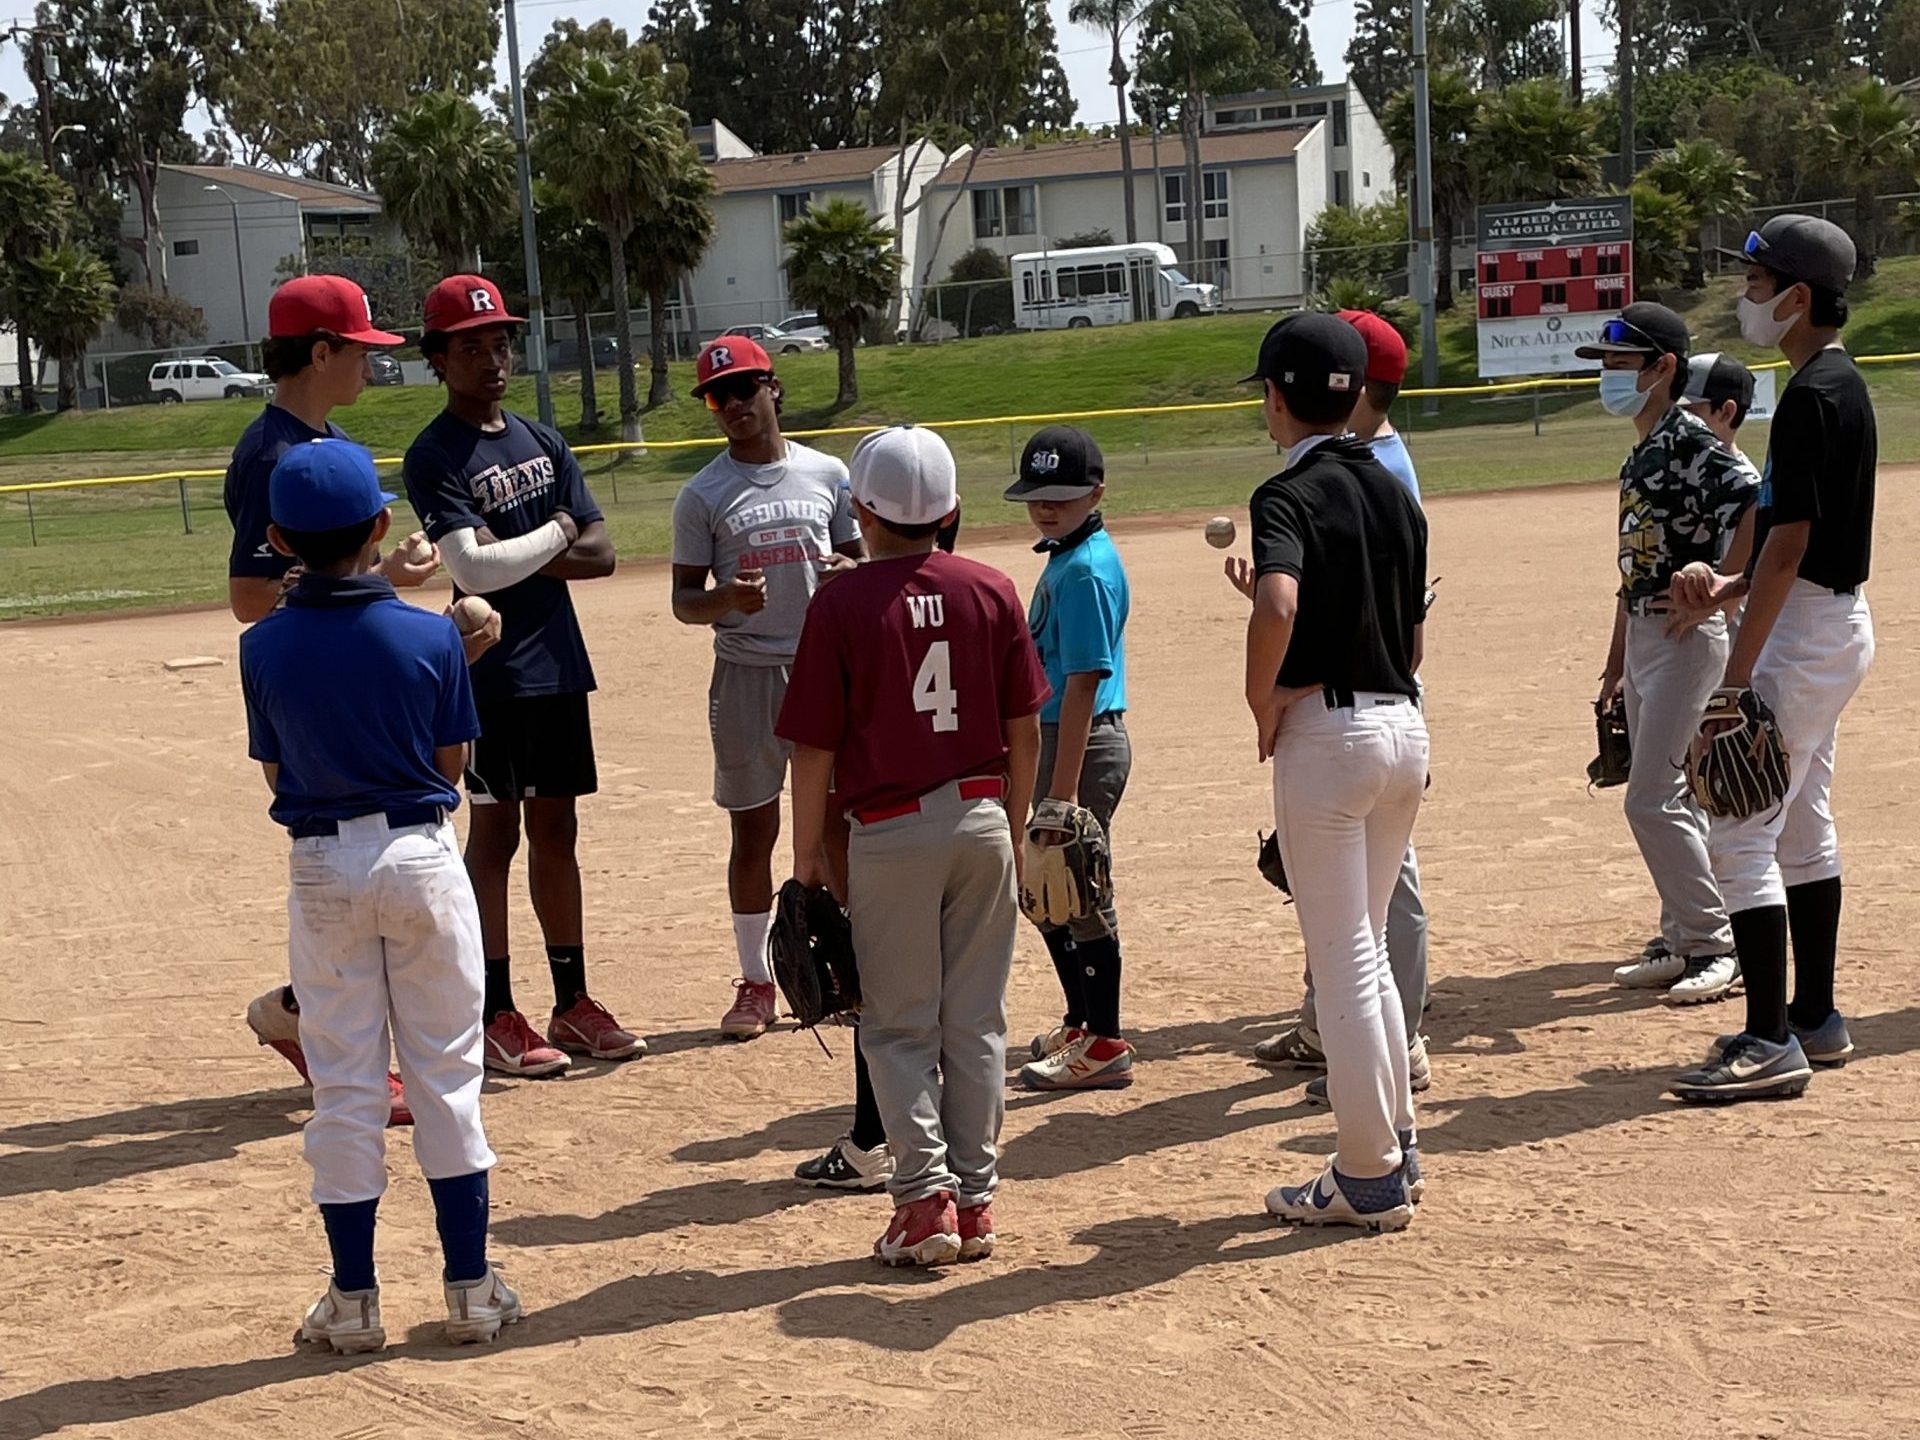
[240,440,520,1354]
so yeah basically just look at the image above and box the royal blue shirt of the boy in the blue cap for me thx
[240,574,480,828]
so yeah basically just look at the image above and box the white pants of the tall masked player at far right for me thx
[1709,580,1874,912]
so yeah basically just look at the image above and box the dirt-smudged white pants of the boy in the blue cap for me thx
[286,814,493,1206]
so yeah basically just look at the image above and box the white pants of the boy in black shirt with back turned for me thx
[1273,693,1428,1179]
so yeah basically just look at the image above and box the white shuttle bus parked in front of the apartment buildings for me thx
[1012,244,1219,330]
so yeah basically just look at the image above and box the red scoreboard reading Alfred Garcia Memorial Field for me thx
[1475,196,1634,376]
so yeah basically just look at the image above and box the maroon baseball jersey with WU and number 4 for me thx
[774,551,1046,812]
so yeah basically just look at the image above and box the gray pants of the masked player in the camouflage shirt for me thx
[1624,614,1734,958]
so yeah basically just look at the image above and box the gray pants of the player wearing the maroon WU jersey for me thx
[847,783,1020,1206]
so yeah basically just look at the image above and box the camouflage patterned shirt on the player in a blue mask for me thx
[1620,405,1761,599]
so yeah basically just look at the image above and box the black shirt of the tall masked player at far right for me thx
[1749,348,1880,589]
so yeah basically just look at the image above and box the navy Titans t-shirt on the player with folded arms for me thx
[403,411,603,701]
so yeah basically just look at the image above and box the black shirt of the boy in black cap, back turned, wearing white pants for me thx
[1252,436,1427,697]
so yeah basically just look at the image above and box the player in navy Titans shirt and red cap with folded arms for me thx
[405,275,647,1075]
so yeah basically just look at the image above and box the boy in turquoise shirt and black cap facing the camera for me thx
[1006,424,1133,1091]
